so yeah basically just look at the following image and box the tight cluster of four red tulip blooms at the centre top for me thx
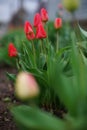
[24,8,48,40]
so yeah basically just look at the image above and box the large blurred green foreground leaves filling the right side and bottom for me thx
[11,31,87,130]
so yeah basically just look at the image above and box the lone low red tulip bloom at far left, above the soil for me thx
[8,43,18,57]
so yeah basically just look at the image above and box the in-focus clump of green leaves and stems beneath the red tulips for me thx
[7,17,71,109]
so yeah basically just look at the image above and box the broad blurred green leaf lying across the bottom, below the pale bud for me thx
[11,105,65,130]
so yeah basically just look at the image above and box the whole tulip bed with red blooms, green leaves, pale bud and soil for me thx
[0,0,87,130]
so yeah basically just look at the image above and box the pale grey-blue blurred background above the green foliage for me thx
[0,0,87,37]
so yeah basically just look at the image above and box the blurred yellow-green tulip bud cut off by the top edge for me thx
[62,0,80,12]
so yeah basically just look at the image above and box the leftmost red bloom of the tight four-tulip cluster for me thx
[24,21,35,40]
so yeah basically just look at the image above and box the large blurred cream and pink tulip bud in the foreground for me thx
[15,72,39,100]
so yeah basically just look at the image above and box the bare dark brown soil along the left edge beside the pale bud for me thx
[0,67,17,130]
